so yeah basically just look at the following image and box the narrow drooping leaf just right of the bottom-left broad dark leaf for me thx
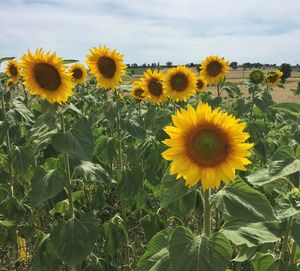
[101,215,126,258]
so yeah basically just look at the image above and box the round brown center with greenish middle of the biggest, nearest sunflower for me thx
[186,126,230,167]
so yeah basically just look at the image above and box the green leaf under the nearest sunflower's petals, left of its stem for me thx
[160,169,190,208]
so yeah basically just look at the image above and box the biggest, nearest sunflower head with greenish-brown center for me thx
[162,104,253,189]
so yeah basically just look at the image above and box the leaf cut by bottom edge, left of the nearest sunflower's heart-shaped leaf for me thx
[136,229,173,271]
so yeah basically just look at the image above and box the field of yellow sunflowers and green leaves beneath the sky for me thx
[0,46,300,271]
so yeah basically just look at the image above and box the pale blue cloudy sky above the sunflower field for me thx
[0,0,300,64]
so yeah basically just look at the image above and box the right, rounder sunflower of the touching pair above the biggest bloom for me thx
[164,66,196,101]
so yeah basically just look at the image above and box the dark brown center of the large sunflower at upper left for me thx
[34,63,61,91]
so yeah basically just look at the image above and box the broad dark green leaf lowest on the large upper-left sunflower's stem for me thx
[50,215,99,266]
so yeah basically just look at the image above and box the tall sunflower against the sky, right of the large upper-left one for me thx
[86,46,126,89]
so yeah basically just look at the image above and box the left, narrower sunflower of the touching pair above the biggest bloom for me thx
[142,69,167,104]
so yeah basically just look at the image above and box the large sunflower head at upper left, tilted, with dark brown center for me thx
[21,49,73,104]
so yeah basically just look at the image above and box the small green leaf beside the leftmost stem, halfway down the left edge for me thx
[11,146,33,174]
